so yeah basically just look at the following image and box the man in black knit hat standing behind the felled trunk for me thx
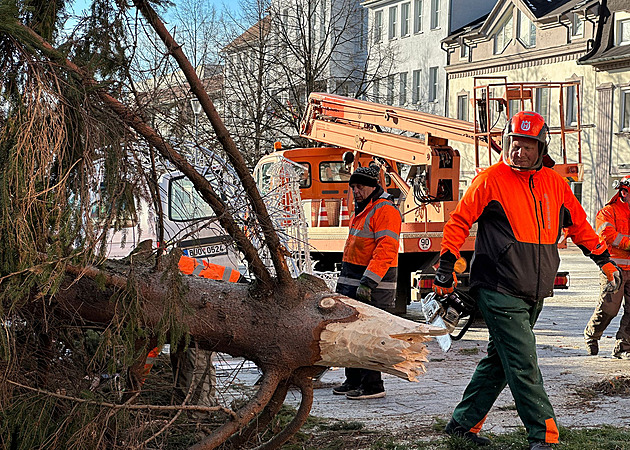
[333,167,402,400]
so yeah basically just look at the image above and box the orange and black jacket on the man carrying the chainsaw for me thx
[442,162,608,300]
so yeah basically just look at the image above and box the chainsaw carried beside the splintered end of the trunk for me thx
[421,289,477,352]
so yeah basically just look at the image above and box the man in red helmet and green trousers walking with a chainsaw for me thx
[433,111,619,450]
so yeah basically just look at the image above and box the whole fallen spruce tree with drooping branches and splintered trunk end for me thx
[0,0,443,449]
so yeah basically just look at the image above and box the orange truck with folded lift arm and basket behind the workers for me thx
[254,78,583,313]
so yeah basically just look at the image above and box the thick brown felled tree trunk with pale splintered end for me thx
[54,252,445,449]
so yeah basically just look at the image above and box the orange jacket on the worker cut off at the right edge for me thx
[595,195,630,270]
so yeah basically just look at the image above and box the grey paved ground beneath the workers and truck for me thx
[287,247,630,433]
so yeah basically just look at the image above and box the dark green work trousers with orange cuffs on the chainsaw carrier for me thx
[453,289,558,443]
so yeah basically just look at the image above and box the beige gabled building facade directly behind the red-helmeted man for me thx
[443,0,608,222]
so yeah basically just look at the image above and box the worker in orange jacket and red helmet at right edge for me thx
[584,175,630,359]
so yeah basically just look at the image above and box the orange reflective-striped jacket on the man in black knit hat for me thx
[337,193,402,307]
